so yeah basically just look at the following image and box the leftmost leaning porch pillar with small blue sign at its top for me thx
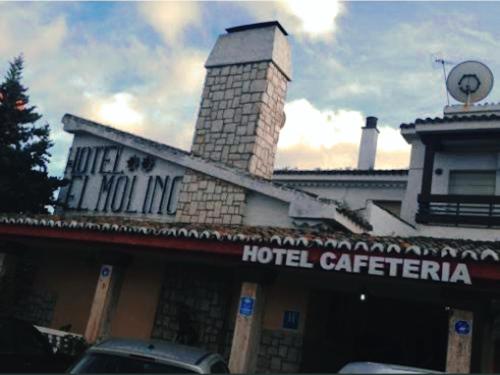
[84,264,120,343]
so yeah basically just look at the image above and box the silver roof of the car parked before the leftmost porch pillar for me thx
[89,338,213,366]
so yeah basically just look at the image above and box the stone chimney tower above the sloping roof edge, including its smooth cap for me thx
[191,22,291,179]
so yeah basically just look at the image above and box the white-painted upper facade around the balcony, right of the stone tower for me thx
[274,105,500,240]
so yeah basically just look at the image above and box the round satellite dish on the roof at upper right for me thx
[446,61,493,105]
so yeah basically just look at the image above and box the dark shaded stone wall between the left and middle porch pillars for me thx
[152,265,232,356]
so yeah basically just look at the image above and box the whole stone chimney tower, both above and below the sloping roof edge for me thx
[176,21,292,225]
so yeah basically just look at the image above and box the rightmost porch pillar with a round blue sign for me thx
[446,309,474,373]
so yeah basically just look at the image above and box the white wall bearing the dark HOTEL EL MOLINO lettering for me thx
[58,134,184,221]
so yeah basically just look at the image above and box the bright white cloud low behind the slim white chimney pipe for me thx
[276,99,410,169]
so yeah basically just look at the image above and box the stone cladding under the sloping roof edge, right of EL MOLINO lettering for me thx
[176,171,246,225]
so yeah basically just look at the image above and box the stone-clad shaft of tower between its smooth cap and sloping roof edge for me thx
[191,62,287,179]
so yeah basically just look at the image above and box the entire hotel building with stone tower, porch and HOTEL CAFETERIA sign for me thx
[0,22,500,372]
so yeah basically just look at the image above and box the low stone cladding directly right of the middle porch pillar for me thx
[257,329,302,373]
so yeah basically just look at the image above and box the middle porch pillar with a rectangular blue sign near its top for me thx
[229,282,263,374]
